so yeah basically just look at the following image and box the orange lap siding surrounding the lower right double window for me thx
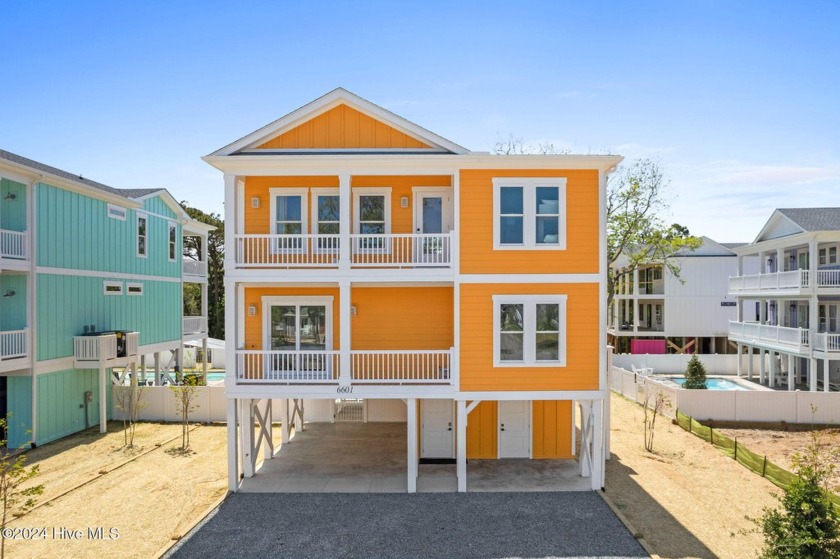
[460,284,600,391]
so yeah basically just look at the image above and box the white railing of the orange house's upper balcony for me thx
[235,232,452,269]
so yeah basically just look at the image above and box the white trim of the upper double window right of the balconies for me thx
[493,177,567,250]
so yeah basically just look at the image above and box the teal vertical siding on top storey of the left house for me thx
[37,183,181,278]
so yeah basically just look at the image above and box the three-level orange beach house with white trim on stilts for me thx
[204,88,621,492]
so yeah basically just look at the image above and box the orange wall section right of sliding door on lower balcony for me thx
[351,287,454,350]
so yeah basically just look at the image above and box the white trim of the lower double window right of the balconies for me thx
[493,295,568,368]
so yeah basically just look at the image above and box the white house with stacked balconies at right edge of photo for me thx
[729,208,840,392]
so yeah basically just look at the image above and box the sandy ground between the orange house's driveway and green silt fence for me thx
[606,394,778,559]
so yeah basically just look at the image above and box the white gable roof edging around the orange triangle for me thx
[208,87,469,157]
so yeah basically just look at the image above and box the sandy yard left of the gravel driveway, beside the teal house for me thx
[6,423,279,558]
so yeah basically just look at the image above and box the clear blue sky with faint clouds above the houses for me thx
[0,0,840,242]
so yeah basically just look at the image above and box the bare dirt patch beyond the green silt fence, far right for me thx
[715,425,840,493]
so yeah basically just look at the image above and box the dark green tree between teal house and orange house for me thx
[181,201,225,340]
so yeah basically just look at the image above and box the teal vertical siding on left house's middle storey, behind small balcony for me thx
[36,274,182,361]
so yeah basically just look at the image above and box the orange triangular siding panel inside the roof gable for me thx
[259,104,429,149]
